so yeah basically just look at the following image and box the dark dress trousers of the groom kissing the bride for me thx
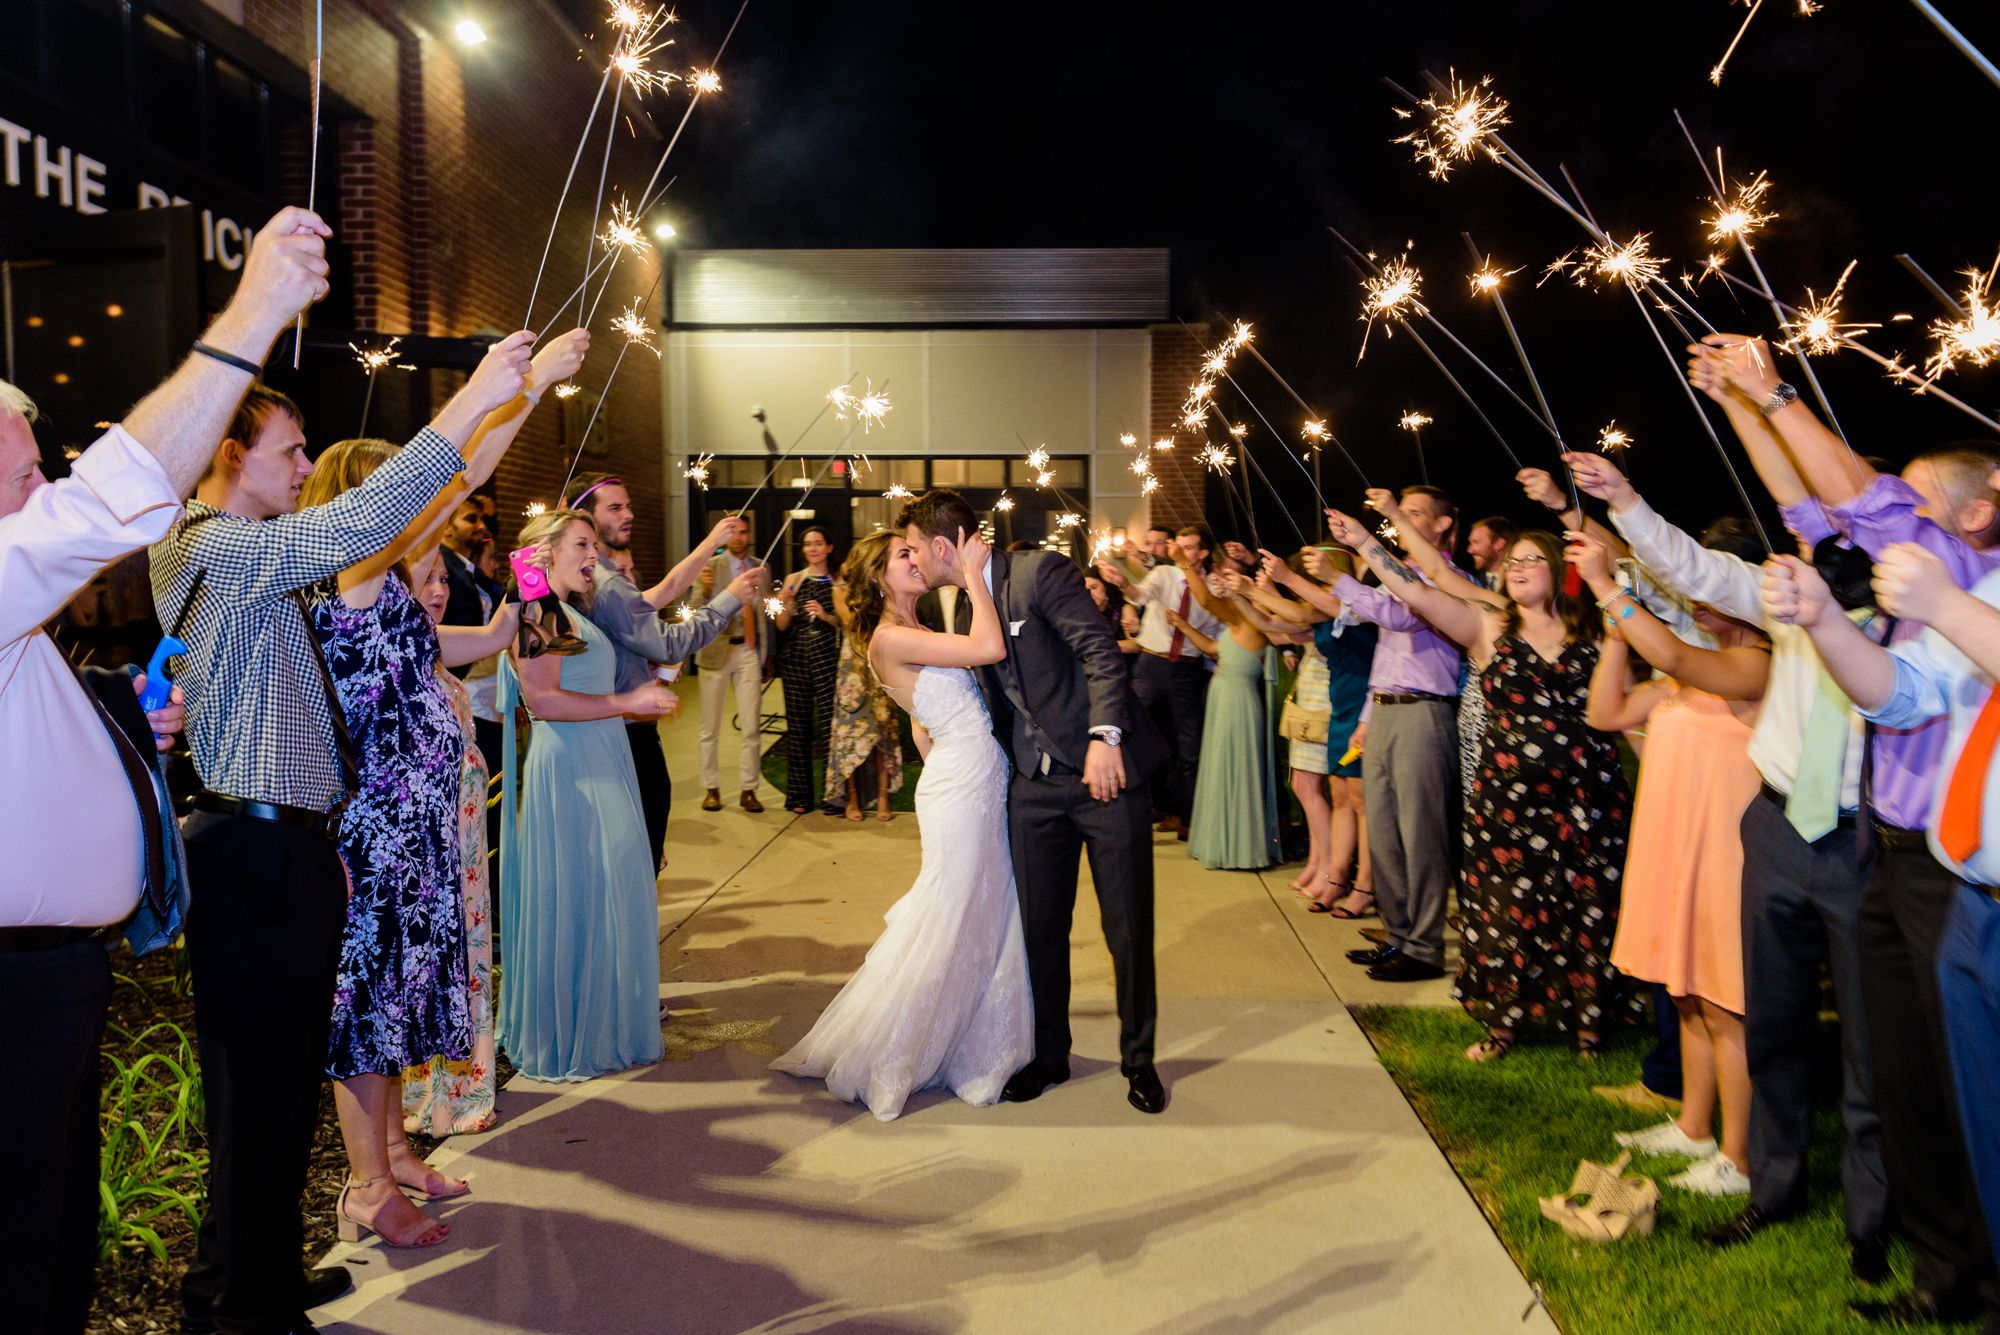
[1006,765,1158,1071]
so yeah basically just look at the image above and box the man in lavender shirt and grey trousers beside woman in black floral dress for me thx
[1332,494,1462,983]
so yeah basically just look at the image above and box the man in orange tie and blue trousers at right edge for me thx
[1766,542,2000,1311]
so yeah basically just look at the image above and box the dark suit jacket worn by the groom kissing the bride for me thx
[960,552,1166,787]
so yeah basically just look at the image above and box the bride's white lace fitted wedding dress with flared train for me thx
[770,668,1034,1121]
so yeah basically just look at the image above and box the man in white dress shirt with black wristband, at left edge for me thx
[0,208,326,1331]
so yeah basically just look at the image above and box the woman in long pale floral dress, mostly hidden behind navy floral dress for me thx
[402,548,514,1137]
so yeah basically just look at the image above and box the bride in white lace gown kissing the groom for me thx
[770,532,1034,1121]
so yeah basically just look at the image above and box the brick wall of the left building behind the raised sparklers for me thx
[244,0,668,578]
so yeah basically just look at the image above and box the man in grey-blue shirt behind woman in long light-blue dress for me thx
[564,474,748,869]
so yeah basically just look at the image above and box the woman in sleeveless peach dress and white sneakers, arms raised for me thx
[1570,536,1770,1195]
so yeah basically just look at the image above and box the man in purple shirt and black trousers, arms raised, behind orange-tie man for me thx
[1690,334,2000,1327]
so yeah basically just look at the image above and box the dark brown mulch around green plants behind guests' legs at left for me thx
[88,945,514,1335]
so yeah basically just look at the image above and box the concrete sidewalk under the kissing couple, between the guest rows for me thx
[316,689,1554,1335]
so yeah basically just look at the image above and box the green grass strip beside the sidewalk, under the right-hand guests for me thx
[1356,1007,1970,1335]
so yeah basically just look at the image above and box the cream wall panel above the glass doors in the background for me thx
[662,330,1150,560]
